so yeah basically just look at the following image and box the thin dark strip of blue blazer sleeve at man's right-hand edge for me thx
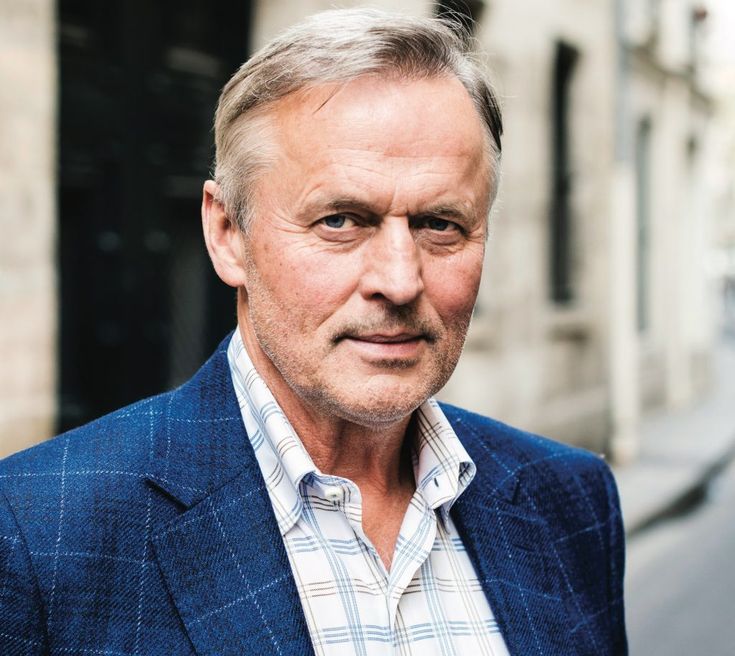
[603,466,628,656]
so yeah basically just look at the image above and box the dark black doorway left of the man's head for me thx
[58,0,251,430]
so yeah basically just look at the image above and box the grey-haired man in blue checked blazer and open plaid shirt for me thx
[0,6,626,656]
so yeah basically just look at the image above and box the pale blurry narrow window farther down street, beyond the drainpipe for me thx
[635,118,651,332]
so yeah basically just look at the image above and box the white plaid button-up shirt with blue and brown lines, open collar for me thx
[227,330,508,656]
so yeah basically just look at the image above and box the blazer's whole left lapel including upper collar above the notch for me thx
[148,337,313,656]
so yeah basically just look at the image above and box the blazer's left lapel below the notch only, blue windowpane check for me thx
[153,472,312,656]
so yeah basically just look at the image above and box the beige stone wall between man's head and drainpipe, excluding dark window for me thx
[443,0,615,450]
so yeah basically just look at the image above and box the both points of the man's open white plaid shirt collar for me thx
[227,330,476,535]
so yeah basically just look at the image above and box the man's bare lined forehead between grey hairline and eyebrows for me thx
[258,76,491,218]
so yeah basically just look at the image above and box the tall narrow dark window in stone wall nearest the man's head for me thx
[550,42,578,303]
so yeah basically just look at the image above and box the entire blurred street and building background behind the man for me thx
[0,0,735,656]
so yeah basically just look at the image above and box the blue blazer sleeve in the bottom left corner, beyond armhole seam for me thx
[0,491,48,656]
